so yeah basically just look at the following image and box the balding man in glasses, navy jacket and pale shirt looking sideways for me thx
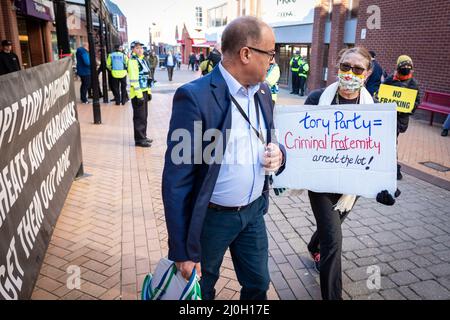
[162,16,286,300]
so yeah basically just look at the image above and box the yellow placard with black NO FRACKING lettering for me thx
[378,84,417,113]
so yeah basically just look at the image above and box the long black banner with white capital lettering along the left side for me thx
[0,58,82,300]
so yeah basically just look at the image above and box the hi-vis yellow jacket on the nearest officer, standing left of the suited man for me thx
[128,53,151,99]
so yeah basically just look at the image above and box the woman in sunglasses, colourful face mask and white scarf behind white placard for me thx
[305,47,400,300]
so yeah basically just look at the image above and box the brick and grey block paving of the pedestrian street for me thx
[33,67,450,300]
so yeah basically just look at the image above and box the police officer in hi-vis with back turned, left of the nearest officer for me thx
[106,45,128,105]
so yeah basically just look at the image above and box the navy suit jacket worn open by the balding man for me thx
[162,67,286,262]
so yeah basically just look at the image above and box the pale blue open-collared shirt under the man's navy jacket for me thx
[210,63,267,207]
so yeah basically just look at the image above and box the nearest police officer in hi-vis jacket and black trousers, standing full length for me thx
[128,41,153,148]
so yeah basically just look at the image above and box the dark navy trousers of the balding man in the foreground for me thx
[200,196,270,300]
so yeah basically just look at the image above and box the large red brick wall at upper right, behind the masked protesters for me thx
[356,0,450,93]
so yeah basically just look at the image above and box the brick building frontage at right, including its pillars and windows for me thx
[308,0,450,94]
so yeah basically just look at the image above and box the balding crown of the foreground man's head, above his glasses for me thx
[222,16,270,55]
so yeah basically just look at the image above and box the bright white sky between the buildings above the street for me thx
[112,0,183,44]
